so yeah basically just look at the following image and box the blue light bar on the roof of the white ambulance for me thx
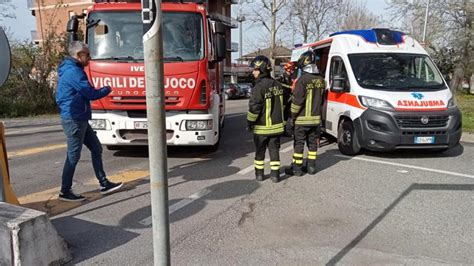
[330,29,405,45]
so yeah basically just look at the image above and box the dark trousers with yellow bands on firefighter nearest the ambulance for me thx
[293,125,320,166]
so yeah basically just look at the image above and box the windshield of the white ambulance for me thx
[349,53,445,90]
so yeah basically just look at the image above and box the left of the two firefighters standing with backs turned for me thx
[247,55,285,183]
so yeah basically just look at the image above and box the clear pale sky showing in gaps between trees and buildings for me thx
[3,0,387,59]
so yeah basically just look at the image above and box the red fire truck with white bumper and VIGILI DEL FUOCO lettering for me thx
[67,0,226,149]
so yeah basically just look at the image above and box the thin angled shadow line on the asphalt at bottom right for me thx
[326,183,474,265]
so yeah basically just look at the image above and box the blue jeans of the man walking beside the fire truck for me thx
[61,119,107,193]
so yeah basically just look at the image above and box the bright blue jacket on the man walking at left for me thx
[56,57,111,120]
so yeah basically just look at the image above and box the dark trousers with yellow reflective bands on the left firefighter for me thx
[253,134,280,170]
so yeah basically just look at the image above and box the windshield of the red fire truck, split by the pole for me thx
[87,11,204,62]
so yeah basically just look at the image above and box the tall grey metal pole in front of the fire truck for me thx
[142,0,171,265]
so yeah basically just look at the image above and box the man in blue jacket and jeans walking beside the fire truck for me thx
[56,41,123,201]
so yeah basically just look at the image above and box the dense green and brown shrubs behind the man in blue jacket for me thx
[0,0,67,117]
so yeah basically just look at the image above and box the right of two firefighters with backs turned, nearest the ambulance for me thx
[285,51,325,176]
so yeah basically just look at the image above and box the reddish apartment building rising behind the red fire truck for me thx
[27,0,238,66]
